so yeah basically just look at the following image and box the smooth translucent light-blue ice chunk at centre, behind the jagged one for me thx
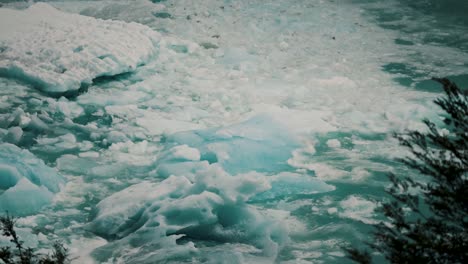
[168,115,299,174]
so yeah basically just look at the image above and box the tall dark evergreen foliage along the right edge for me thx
[346,79,468,264]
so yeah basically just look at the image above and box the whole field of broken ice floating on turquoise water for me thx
[0,0,468,263]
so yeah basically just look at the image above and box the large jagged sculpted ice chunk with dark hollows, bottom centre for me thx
[90,161,287,262]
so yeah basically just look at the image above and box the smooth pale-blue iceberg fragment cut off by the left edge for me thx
[0,143,64,215]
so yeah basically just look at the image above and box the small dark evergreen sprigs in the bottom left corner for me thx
[0,213,68,264]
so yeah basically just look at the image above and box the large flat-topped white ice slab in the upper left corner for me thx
[0,3,159,93]
